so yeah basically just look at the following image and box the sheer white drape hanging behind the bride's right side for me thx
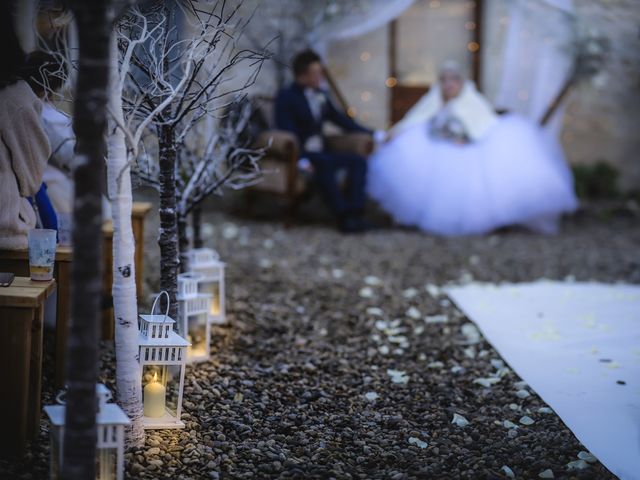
[495,0,575,132]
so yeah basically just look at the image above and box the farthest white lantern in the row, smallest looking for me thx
[187,248,226,325]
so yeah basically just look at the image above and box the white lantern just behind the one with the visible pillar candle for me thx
[177,273,211,362]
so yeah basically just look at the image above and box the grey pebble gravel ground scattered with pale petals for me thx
[0,197,640,479]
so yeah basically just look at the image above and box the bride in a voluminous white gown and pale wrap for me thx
[368,62,578,236]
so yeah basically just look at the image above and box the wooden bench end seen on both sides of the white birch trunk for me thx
[102,202,152,340]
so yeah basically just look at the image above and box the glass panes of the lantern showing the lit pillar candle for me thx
[142,365,182,418]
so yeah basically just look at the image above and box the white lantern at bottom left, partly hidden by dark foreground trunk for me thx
[44,383,130,480]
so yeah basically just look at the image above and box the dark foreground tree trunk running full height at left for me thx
[62,0,113,480]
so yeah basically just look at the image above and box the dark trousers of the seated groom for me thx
[304,152,367,215]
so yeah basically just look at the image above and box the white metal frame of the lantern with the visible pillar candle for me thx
[139,292,191,430]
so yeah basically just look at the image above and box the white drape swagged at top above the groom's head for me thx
[309,0,415,54]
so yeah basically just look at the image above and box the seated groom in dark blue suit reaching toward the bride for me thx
[275,50,373,233]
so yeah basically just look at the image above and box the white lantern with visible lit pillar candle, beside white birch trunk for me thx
[139,292,191,429]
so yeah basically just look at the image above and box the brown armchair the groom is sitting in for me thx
[251,97,374,226]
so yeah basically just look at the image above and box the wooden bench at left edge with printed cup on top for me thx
[0,277,56,458]
